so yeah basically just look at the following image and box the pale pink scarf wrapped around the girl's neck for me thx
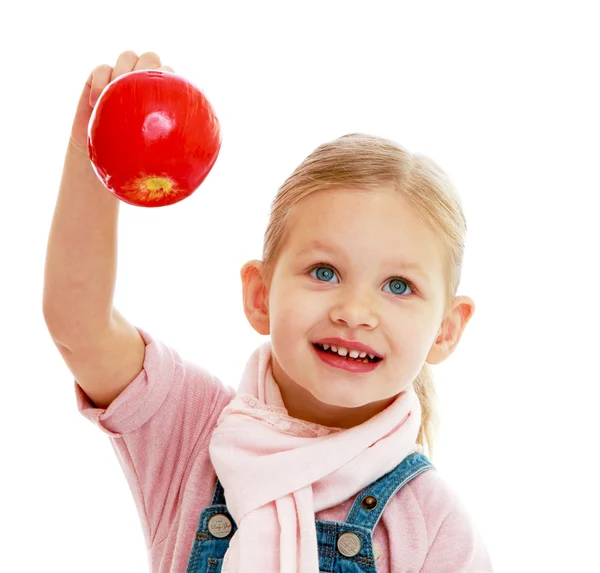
[210,343,422,573]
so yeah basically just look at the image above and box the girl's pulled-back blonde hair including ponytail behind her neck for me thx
[263,133,467,457]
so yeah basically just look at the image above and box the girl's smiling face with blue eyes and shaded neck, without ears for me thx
[254,188,468,427]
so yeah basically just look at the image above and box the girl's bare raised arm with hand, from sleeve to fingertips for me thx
[43,51,172,408]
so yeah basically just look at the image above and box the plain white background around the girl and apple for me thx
[0,0,600,573]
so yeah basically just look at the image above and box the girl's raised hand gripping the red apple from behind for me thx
[69,50,174,156]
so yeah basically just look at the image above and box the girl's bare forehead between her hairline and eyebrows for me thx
[283,187,441,272]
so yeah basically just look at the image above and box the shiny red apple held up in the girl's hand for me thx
[88,70,221,207]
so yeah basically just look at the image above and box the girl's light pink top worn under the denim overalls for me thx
[75,328,492,573]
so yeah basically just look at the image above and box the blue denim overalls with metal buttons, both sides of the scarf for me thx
[186,453,435,573]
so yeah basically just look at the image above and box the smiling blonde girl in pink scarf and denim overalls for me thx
[44,52,492,573]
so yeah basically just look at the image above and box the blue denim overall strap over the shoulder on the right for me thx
[346,452,435,532]
